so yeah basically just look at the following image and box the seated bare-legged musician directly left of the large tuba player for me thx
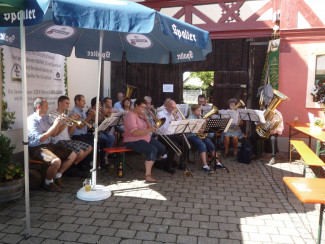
[221,98,244,157]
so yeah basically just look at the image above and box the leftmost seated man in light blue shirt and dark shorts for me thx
[27,97,77,191]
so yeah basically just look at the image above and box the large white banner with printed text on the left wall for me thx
[1,46,66,129]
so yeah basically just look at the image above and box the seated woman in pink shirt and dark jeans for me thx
[124,98,165,183]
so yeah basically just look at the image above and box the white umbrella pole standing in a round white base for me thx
[77,30,111,201]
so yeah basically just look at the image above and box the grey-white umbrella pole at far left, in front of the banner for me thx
[20,10,30,239]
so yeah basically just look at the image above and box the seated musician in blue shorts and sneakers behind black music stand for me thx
[188,105,225,173]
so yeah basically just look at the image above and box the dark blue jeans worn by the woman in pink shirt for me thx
[124,137,165,161]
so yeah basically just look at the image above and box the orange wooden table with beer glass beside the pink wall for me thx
[286,122,325,157]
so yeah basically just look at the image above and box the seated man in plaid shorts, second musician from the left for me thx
[52,96,93,165]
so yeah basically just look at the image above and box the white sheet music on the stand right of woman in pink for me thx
[168,119,205,134]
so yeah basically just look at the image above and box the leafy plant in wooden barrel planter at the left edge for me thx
[0,133,24,202]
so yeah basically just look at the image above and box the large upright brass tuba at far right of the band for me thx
[256,89,288,139]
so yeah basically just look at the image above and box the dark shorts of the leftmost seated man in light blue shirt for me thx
[29,143,72,164]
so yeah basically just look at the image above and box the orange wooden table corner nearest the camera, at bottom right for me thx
[283,177,325,243]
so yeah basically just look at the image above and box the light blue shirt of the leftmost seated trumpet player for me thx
[27,112,51,147]
